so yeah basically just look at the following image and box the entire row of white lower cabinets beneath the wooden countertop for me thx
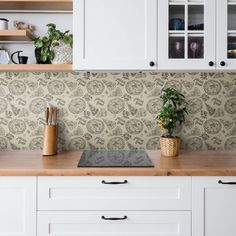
[3,176,236,236]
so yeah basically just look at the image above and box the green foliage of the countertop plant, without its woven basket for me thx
[156,88,188,138]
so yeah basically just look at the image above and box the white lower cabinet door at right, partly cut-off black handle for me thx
[192,177,236,236]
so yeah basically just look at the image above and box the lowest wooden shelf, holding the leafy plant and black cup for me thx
[0,64,72,72]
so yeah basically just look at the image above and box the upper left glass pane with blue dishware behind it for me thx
[169,5,185,30]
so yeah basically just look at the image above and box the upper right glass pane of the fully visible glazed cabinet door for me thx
[188,5,204,30]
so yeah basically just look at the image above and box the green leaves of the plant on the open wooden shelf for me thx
[34,23,73,63]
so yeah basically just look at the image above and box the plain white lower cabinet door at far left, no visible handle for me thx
[0,177,36,236]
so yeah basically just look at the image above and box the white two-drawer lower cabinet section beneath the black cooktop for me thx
[37,176,191,236]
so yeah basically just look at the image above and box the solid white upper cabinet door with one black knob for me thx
[73,0,157,70]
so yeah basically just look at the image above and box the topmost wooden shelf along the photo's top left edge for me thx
[0,0,73,11]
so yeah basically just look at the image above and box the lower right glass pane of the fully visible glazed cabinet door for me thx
[188,37,204,58]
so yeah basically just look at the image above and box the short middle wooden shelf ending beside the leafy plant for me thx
[0,30,35,41]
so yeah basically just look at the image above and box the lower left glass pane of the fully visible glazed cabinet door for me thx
[169,37,185,58]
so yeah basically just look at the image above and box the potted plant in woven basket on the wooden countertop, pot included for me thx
[156,88,188,157]
